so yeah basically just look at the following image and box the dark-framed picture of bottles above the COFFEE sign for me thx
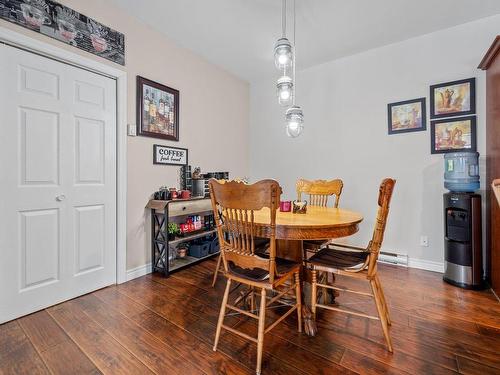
[137,76,179,141]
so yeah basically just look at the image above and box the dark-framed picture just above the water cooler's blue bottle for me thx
[431,116,477,154]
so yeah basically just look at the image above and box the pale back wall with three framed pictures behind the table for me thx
[250,16,500,270]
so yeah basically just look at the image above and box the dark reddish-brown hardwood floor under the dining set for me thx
[0,260,500,375]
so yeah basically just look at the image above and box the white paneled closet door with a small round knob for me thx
[0,44,116,323]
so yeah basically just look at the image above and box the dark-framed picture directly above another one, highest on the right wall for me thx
[430,78,476,118]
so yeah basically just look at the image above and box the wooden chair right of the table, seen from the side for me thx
[309,178,396,352]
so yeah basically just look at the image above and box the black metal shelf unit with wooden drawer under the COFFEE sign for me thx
[146,198,219,276]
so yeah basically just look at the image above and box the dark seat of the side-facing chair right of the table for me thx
[308,246,370,269]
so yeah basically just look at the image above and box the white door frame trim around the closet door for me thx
[0,25,127,284]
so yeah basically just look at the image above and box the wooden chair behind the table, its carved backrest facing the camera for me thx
[295,178,344,259]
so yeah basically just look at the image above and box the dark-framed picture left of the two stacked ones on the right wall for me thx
[387,98,427,134]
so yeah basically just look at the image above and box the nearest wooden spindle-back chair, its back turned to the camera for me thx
[209,179,302,374]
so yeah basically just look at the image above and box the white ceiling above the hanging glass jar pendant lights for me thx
[112,0,500,82]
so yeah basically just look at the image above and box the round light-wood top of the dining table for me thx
[254,206,363,240]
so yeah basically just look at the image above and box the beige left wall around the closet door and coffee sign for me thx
[0,0,249,271]
